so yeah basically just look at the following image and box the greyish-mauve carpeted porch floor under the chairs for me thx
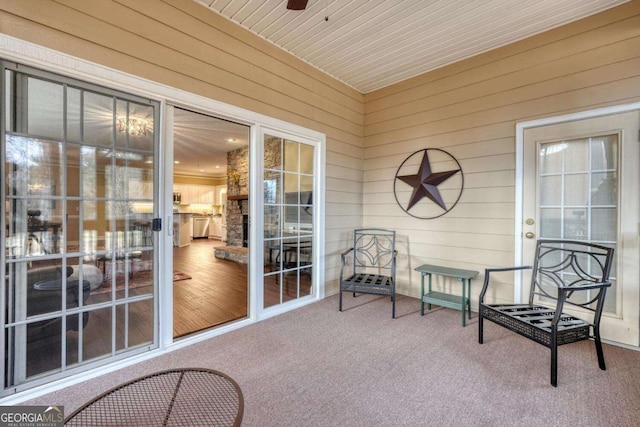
[27,296,640,427]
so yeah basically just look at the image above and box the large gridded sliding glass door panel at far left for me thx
[0,63,159,394]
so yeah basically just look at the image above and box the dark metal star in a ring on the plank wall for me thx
[393,148,464,219]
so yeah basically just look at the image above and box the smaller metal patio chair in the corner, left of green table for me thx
[340,228,398,319]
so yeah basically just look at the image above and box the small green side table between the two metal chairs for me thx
[415,264,478,326]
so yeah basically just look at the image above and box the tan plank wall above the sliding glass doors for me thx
[0,0,364,290]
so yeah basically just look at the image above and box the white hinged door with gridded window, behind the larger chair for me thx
[522,110,640,346]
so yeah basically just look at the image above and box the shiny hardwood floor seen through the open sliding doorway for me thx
[173,239,249,337]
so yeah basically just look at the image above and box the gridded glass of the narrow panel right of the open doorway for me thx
[263,135,315,308]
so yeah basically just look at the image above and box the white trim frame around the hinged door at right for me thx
[513,102,640,303]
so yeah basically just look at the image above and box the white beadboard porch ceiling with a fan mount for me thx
[194,0,629,93]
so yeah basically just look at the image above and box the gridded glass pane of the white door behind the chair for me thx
[537,135,618,313]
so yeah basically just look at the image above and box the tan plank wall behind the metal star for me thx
[363,1,640,307]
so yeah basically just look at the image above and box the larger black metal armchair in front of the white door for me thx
[478,240,614,387]
